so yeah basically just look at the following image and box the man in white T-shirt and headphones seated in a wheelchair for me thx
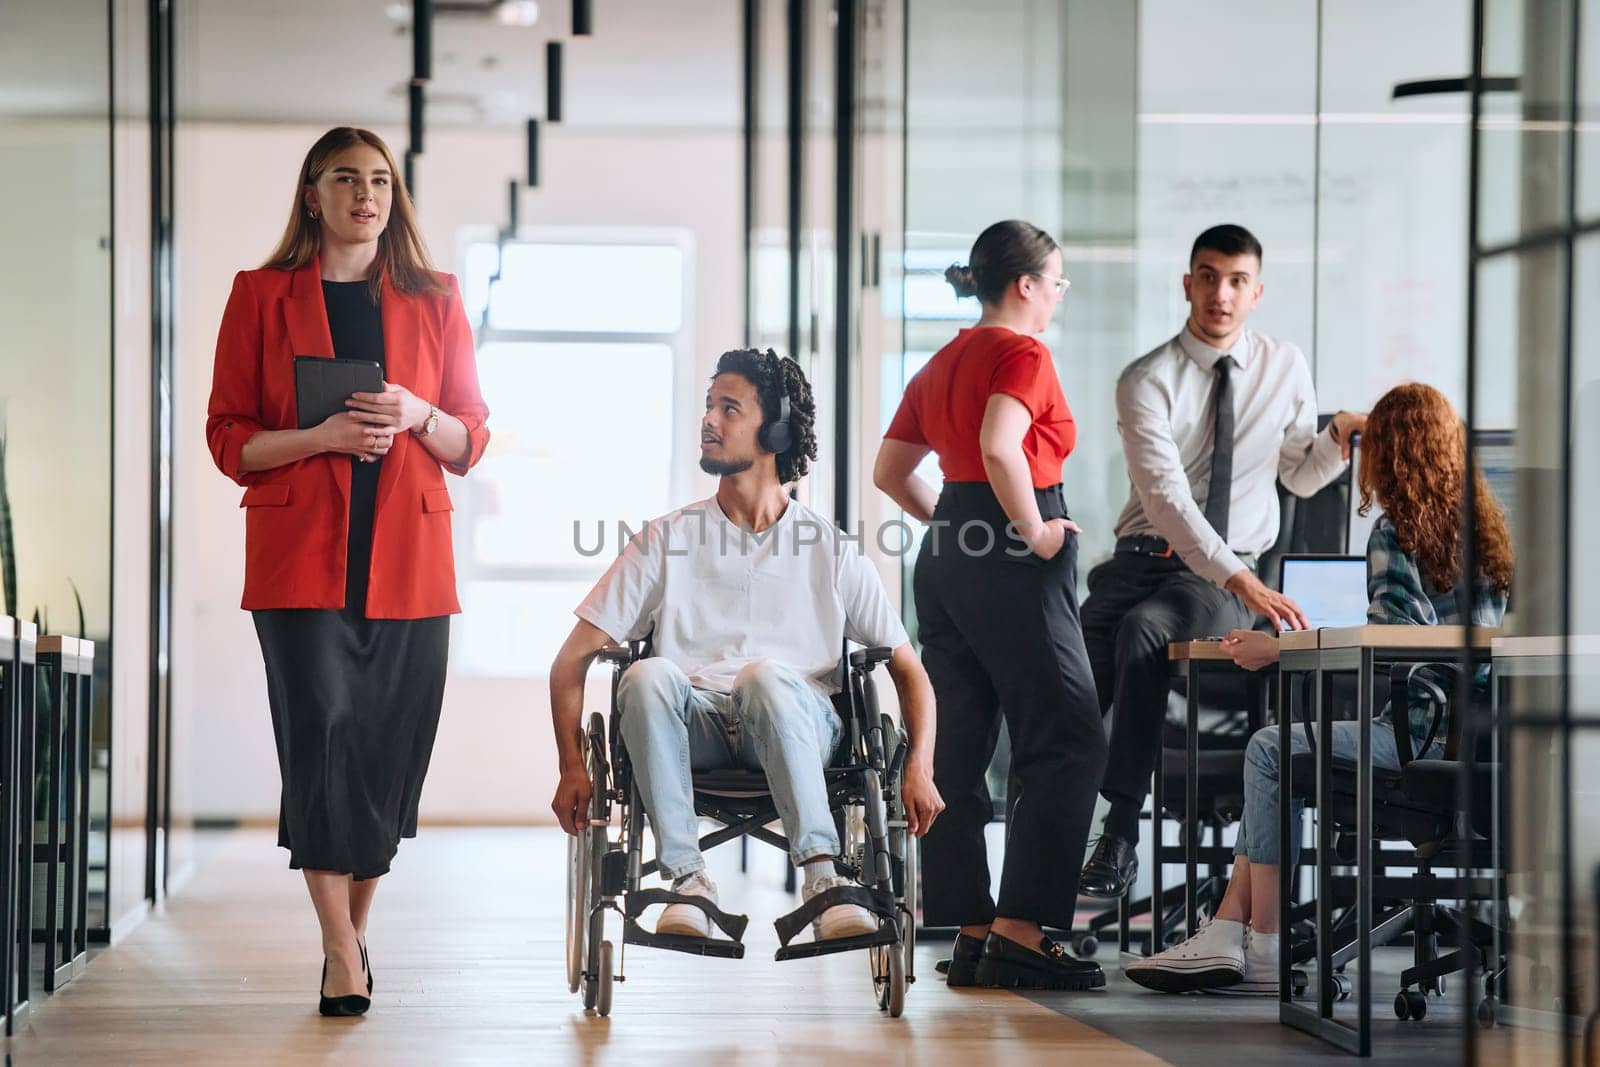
[550,350,944,942]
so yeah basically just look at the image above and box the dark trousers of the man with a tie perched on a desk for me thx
[1083,552,1253,841]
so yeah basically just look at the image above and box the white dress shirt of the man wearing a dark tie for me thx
[1117,323,1344,585]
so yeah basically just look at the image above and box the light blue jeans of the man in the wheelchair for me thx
[616,657,845,878]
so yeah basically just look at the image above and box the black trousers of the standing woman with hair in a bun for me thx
[914,482,1106,929]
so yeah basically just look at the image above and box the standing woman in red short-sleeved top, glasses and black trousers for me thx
[874,221,1106,989]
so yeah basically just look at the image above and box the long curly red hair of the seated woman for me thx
[1360,382,1512,590]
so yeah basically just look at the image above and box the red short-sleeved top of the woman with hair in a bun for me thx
[883,326,1078,490]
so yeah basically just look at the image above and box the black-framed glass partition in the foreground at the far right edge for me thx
[1467,0,1600,1064]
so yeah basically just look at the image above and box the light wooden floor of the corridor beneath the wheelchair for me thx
[10,829,1163,1067]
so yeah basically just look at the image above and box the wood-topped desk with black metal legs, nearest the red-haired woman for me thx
[1278,625,1499,1056]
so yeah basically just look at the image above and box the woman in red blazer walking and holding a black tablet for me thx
[206,126,490,1014]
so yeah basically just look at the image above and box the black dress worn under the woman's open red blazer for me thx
[253,282,450,880]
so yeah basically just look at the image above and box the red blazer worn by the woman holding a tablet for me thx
[205,261,490,619]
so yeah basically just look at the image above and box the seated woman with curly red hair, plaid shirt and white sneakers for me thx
[1126,382,1512,997]
